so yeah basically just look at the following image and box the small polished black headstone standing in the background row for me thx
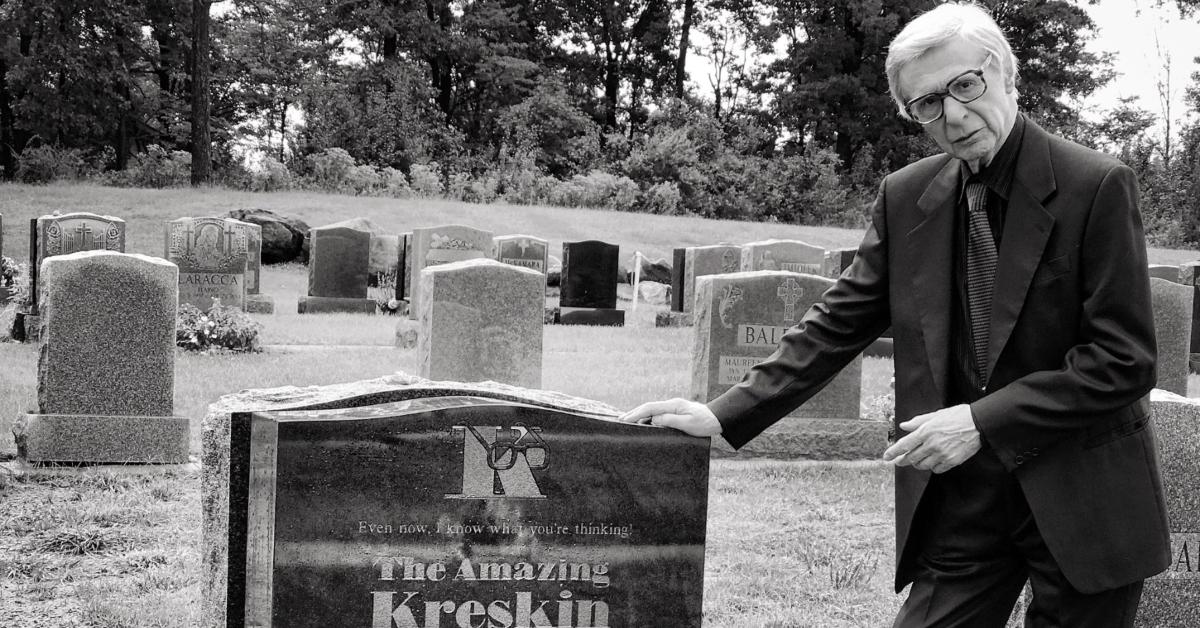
[558,240,625,327]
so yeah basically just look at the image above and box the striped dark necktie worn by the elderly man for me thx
[967,183,997,385]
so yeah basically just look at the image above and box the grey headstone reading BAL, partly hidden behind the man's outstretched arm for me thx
[690,270,888,459]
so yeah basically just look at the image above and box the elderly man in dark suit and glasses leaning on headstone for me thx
[623,5,1170,628]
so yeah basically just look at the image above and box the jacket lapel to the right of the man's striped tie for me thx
[988,119,1055,378]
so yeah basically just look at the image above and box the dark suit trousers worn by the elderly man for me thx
[893,444,1142,628]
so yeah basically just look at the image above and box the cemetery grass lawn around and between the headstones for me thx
[0,185,1200,628]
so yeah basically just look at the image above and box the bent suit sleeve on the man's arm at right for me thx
[971,166,1157,469]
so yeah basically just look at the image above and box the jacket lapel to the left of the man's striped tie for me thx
[907,159,959,399]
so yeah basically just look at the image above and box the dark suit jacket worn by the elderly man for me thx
[709,121,1170,593]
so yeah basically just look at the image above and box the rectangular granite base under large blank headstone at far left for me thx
[12,413,188,463]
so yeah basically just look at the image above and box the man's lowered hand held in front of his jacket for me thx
[883,403,983,473]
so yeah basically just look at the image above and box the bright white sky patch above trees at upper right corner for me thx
[1079,0,1200,132]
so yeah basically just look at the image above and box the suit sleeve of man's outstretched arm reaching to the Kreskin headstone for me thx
[708,179,890,448]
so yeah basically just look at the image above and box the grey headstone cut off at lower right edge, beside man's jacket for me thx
[1132,390,1200,628]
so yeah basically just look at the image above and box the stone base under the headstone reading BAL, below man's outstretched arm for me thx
[713,417,890,460]
